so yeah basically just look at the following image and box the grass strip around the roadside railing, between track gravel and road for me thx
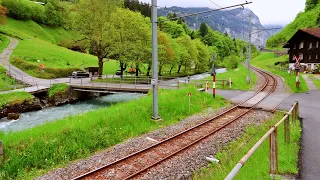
[194,113,301,180]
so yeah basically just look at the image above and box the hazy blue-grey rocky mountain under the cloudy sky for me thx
[158,6,273,47]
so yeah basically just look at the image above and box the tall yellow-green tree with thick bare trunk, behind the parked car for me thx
[74,0,120,75]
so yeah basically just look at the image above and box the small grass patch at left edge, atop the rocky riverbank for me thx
[0,92,33,108]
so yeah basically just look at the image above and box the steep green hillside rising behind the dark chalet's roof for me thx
[267,4,320,48]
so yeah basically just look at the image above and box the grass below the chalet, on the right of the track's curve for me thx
[252,52,308,93]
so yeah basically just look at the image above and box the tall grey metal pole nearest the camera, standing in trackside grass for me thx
[151,0,160,120]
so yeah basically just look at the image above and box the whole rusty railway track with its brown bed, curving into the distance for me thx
[74,67,277,180]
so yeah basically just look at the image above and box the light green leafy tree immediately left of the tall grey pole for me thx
[110,8,151,75]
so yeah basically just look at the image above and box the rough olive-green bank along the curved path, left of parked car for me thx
[11,57,81,79]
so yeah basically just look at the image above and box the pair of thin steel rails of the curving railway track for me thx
[73,68,277,180]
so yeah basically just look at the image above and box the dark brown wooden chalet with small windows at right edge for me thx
[284,28,320,71]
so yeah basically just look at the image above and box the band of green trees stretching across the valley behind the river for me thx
[1,0,258,76]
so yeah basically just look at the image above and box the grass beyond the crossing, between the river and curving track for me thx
[195,64,257,90]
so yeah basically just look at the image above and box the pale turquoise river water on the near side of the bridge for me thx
[0,93,144,132]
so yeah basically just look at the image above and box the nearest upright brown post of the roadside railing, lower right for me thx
[269,126,278,175]
